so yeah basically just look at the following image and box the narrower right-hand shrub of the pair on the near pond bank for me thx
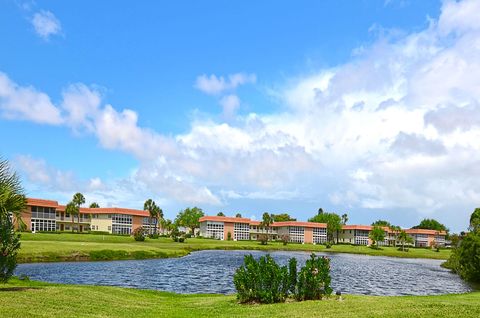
[295,253,332,301]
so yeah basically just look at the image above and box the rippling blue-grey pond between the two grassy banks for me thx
[16,250,472,295]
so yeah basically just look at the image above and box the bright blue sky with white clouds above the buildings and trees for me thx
[0,0,480,232]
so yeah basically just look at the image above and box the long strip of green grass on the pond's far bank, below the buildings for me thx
[15,233,450,263]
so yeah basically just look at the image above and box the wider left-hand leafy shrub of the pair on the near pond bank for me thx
[233,255,290,304]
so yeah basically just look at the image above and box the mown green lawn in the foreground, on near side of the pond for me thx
[0,280,480,318]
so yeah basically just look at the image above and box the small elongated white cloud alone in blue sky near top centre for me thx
[195,73,257,95]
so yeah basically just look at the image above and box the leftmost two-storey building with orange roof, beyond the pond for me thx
[21,198,159,235]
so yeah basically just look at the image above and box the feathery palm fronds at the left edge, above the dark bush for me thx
[0,158,27,230]
